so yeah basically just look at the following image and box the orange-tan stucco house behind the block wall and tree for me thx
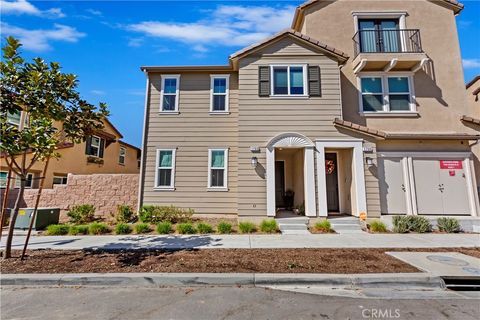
[0,112,140,189]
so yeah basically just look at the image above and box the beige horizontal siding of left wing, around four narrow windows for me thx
[143,74,238,214]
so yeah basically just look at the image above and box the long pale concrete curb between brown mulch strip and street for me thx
[0,273,445,290]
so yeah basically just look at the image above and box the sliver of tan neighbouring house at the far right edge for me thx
[462,75,480,193]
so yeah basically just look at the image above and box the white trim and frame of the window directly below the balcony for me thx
[357,72,418,117]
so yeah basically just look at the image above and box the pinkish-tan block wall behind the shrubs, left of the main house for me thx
[2,174,138,220]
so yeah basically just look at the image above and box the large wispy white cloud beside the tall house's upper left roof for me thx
[126,5,294,53]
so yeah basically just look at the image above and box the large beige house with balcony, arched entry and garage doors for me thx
[139,0,479,219]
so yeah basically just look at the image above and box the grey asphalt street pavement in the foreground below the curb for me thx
[1,286,480,320]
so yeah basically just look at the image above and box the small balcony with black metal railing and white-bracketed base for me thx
[353,29,428,73]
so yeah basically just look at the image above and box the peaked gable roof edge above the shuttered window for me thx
[229,29,348,62]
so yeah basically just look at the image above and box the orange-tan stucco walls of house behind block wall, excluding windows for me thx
[0,122,140,188]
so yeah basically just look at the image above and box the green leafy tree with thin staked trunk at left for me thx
[0,37,108,258]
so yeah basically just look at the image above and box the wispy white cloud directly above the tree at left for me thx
[1,22,85,52]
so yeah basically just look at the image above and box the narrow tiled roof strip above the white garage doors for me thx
[333,118,480,140]
